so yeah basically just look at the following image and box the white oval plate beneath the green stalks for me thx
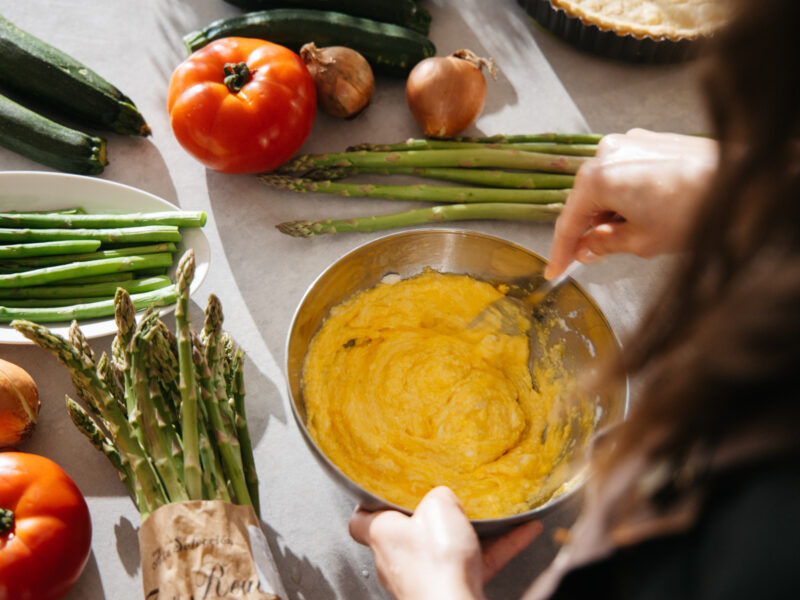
[0,171,211,344]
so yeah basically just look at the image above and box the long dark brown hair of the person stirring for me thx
[600,0,800,473]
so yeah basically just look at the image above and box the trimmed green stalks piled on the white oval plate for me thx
[0,209,206,323]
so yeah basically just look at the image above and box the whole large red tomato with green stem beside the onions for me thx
[167,37,317,173]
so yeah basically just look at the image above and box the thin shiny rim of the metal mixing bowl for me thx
[284,227,631,533]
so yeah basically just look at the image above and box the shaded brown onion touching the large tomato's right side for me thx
[300,42,375,119]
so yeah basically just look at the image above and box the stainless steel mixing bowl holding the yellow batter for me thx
[286,229,628,535]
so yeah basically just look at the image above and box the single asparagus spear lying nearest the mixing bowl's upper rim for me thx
[276,203,563,237]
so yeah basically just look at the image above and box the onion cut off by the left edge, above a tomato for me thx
[0,358,41,448]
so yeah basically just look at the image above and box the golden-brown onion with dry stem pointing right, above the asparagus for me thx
[406,50,495,138]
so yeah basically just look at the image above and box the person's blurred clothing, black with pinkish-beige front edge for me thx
[524,416,800,600]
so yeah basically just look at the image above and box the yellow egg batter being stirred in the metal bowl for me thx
[302,270,571,519]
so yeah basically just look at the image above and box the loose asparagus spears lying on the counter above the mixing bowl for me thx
[261,133,602,237]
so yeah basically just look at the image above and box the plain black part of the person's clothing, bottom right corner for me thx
[553,456,800,600]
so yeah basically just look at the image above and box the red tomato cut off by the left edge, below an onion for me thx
[0,452,92,600]
